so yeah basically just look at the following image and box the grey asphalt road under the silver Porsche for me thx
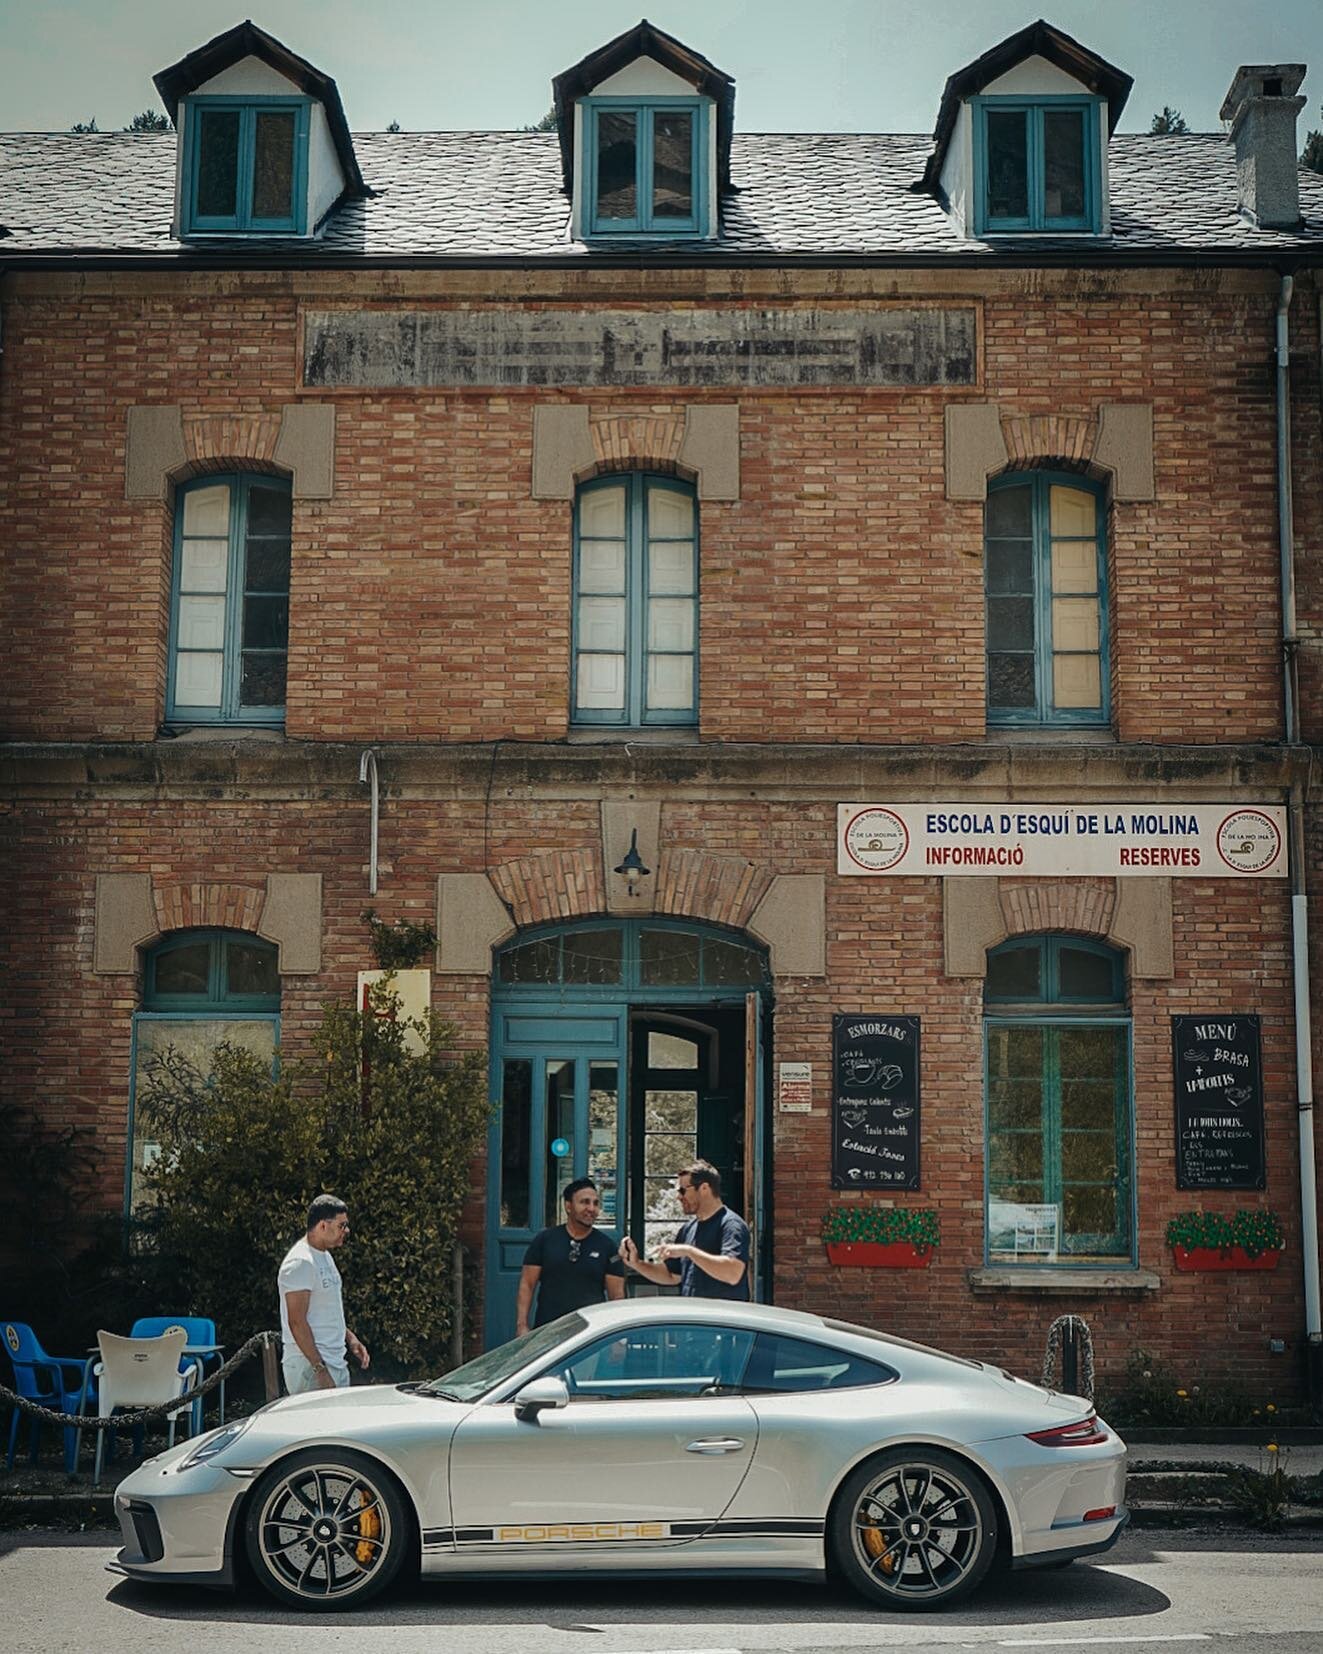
[0,1530,1323,1654]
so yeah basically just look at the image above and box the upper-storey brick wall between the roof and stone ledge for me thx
[0,273,1316,743]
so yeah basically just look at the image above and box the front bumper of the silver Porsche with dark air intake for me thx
[111,1447,250,1585]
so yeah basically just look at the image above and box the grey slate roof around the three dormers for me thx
[0,132,1323,265]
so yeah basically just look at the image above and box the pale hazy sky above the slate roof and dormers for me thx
[0,0,1323,142]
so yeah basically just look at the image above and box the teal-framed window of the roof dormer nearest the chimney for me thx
[974,98,1101,235]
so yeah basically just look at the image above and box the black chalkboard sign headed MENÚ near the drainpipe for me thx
[1171,1016,1263,1189]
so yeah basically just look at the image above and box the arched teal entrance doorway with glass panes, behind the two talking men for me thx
[485,918,771,1348]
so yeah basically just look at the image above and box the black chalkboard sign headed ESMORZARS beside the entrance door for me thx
[832,1016,919,1189]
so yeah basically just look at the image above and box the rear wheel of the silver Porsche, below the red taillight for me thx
[830,1447,997,1611]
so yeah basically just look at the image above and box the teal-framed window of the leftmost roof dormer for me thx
[184,98,309,235]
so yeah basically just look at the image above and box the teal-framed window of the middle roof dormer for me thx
[584,98,708,235]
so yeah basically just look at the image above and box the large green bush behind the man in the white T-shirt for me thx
[136,987,490,1378]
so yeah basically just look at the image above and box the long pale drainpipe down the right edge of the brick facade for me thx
[1277,275,1323,1416]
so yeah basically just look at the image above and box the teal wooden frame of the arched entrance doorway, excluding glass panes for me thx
[483,918,772,1348]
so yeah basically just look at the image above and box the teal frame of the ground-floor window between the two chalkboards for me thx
[982,935,1139,1269]
